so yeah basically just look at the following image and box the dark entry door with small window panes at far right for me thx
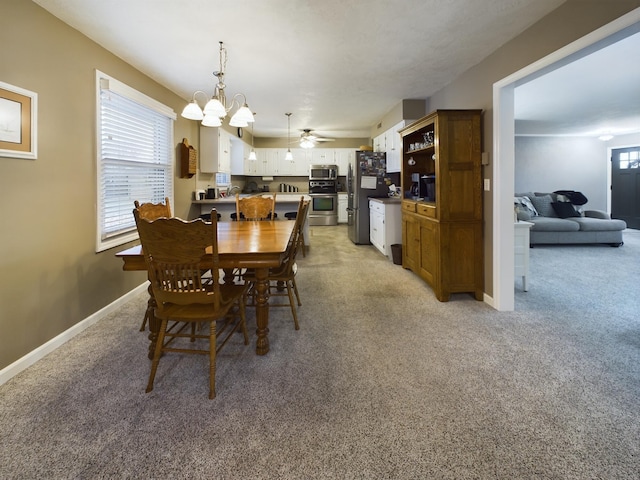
[611,146,640,229]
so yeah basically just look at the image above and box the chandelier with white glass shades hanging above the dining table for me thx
[182,42,255,127]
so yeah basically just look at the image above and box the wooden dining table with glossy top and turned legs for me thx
[116,220,296,358]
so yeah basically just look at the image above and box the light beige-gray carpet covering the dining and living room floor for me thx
[0,226,640,479]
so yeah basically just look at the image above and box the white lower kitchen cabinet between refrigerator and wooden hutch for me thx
[369,199,402,259]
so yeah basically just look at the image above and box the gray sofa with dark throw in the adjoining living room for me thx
[514,190,627,247]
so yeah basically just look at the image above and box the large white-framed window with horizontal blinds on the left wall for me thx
[96,71,176,252]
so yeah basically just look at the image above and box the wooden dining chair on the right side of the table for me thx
[244,197,309,330]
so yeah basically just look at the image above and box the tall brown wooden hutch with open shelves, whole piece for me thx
[400,110,483,301]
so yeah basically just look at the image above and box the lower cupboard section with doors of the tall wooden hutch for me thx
[402,205,484,302]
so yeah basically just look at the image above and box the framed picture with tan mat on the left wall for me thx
[0,82,38,159]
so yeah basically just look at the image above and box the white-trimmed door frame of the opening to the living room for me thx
[490,8,640,311]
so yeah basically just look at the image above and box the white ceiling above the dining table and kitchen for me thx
[34,0,640,138]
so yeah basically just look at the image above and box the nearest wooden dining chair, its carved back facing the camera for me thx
[133,209,249,398]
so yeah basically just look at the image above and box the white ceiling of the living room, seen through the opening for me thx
[515,26,640,137]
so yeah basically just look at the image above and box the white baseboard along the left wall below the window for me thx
[0,282,148,385]
